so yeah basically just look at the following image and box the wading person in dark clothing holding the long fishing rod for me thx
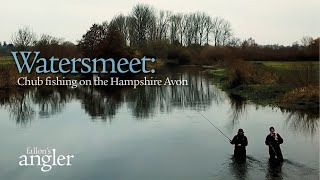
[230,129,248,160]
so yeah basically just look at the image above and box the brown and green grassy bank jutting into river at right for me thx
[208,62,319,113]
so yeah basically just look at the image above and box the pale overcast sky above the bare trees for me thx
[0,0,320,45]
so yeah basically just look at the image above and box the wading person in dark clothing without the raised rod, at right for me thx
[265,127,283,161]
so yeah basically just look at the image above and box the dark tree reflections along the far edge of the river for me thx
[0,68,319,136]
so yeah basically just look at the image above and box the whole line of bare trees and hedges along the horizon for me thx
[0,4,319,64]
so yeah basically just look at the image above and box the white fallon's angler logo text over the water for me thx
[19,147,74,172]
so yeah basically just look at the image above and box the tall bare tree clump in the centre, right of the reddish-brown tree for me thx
[110,4,232,46]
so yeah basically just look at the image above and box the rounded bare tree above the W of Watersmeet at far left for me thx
[11,26,36,50]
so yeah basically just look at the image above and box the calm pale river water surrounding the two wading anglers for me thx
[0,67,319,180]
